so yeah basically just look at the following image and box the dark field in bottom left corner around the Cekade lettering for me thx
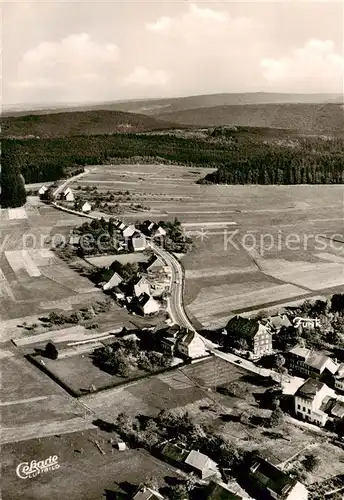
[1,429,176,500]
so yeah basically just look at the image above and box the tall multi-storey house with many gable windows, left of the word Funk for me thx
[225,316,272,358]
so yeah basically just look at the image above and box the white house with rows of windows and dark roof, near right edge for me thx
[294,378,336,426]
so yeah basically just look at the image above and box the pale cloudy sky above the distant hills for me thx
[2,0,344,108]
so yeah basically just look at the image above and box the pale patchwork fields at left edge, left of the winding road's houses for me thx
[0,197,143,342]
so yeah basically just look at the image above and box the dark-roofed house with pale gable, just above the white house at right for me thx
[286,346,338,380]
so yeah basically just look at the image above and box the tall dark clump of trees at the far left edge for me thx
[0,144,26,208]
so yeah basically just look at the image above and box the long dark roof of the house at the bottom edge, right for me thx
[250,457,297,498]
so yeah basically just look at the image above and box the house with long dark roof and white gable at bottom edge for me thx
[247,457,308,500]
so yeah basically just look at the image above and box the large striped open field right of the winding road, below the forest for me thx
[75,165,344,328]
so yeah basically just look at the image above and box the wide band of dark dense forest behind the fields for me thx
[2,129,344,188]
